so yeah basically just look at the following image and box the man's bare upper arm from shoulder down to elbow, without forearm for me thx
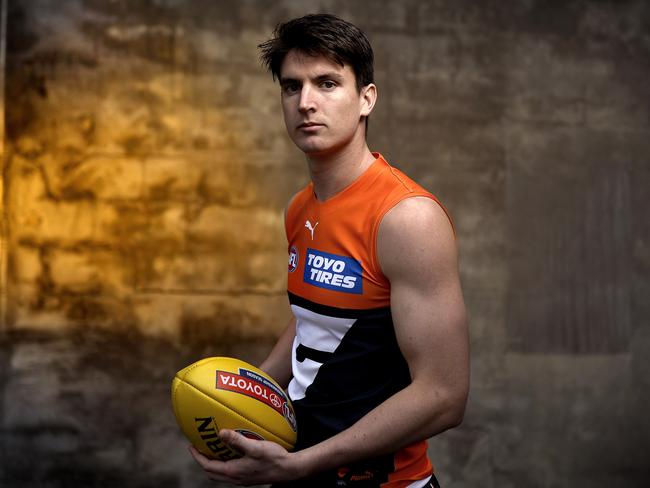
[378,198,469,437]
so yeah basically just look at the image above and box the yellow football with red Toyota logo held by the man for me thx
[172,357,296,461]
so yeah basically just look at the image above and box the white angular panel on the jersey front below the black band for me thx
[289,305,356,401]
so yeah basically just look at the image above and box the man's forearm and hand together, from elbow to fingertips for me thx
[185,381,464,485]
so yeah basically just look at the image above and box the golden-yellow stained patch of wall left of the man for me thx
[3,35,304,340]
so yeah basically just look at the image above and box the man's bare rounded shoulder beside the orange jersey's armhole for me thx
[377,197,457,279]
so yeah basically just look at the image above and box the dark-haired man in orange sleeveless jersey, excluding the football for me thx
[191,15,469,488]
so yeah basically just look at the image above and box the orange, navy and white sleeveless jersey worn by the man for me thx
[285,153,444,488]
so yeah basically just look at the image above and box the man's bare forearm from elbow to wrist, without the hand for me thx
[293,381,466,476]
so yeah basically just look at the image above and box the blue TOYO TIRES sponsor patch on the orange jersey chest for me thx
[303,249,363,295]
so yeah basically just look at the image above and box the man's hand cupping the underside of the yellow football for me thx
[190,429,301,486]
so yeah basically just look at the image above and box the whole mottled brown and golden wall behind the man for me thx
[0,0,650,488]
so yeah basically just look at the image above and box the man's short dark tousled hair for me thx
[257,14,374,91]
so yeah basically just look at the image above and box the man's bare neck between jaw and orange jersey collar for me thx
[307,134,375,202]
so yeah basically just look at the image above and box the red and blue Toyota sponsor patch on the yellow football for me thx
[217,368,297,432]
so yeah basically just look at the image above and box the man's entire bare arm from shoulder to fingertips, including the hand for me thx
[190,198,469,483]
